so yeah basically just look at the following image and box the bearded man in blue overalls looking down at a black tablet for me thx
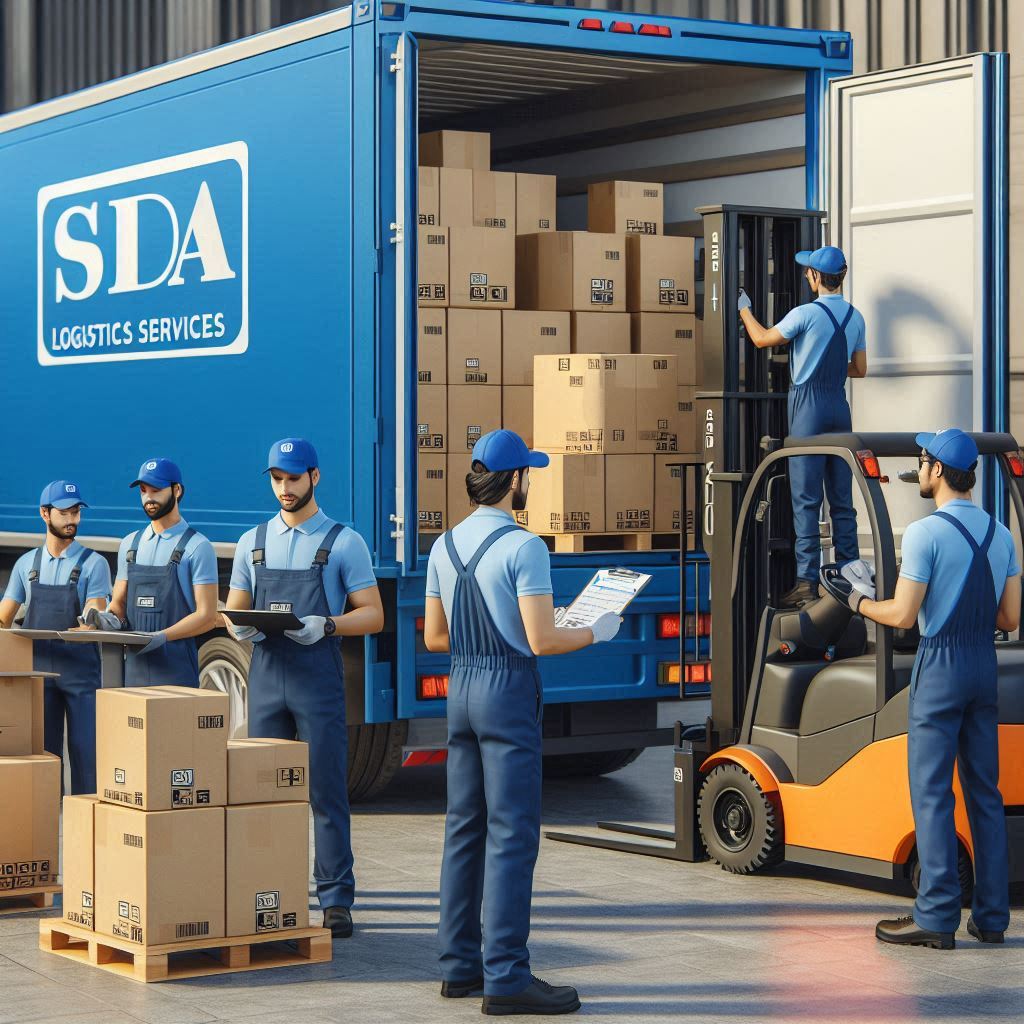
[227,437,384,938]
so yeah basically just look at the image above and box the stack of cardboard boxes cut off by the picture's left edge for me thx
[0,630,60,898]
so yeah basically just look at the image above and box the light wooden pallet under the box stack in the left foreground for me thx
[39,921,331,982]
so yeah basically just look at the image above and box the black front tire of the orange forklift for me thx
[697,764,784,874]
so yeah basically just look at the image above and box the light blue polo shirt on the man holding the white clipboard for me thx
[427,506,552,656]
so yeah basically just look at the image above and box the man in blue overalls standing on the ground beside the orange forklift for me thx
[850,428,1021,949]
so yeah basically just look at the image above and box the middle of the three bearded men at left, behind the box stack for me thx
[85,459,220,686]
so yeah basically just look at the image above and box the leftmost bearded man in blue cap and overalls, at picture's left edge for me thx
[0,480,111,793]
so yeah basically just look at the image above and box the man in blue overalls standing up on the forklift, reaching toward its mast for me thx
[738,246,867,607]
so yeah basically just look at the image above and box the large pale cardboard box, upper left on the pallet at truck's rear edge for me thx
[534,353,637,455]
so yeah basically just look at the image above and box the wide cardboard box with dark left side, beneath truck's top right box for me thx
[516,231,626,312]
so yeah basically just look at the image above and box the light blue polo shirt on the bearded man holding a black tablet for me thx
[231,509,377,615]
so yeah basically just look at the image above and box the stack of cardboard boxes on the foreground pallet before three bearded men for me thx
[63,686,309,946]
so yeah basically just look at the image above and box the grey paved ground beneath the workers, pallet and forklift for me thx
[0,750,1024,1024]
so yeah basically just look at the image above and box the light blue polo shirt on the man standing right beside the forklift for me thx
[899,499,1021,637]
